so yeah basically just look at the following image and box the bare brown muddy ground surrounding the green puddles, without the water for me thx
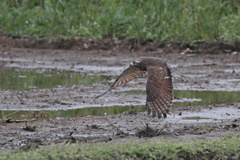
[0,37,240,152]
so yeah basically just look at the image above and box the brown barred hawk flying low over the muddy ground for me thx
[96,57,173,118]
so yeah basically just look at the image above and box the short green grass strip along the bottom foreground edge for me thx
[0,137,240,160]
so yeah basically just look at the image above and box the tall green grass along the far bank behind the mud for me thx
[0,0,240,43]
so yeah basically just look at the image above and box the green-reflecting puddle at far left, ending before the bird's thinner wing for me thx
[0,68,109,90]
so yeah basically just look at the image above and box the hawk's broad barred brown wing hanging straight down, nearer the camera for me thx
[146,65,173,118]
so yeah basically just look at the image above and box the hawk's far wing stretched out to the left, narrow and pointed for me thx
[95,66,146,98]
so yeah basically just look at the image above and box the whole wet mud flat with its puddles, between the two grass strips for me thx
[0,41,240,152]
